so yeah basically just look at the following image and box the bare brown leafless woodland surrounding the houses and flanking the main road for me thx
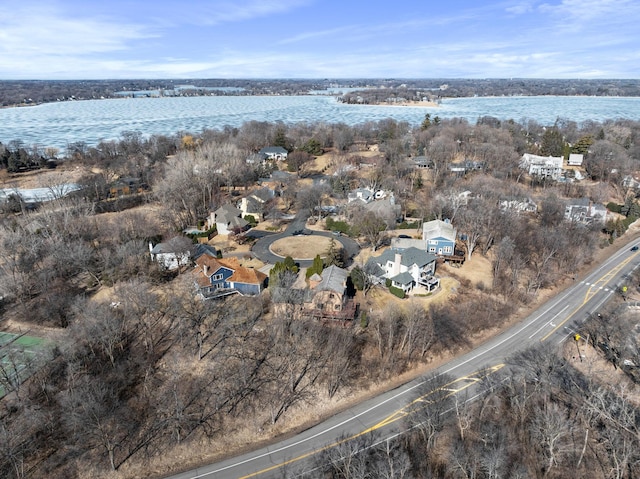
[0,113,640,479]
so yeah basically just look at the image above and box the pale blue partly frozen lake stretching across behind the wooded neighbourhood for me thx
[0,95,640,148]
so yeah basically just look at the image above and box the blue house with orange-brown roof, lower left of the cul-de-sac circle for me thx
[193,254,267,298]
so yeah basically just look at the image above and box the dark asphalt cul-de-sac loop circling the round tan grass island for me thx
[251,210,360,268]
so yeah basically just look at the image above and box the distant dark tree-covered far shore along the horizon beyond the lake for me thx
[0,78,640,107]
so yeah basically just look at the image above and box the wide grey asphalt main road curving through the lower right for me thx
[166,245,640,479]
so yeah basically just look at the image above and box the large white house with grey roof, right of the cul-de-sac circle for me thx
[369,247,440,293]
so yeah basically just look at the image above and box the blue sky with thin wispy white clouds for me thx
[0,0,640,80]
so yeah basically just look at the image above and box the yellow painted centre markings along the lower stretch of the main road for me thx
[239,364,505,479]
